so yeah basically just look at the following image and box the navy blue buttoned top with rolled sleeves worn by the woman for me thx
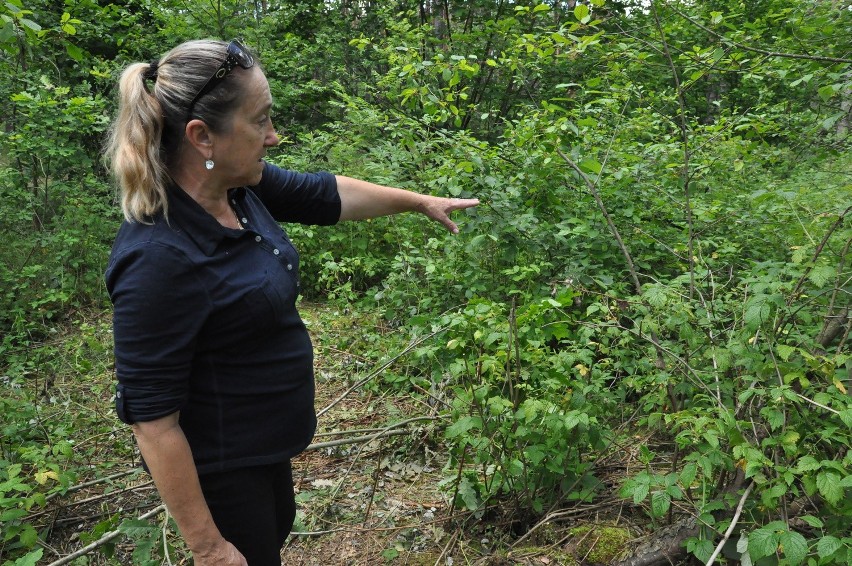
[106,164,340,473]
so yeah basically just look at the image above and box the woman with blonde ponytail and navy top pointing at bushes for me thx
[106,41,478,566]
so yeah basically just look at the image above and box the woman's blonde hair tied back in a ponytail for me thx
[105,40,253,223]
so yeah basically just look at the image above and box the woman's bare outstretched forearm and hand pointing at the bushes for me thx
[336,175,479,234]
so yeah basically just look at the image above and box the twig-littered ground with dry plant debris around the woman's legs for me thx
[11,305,664,566]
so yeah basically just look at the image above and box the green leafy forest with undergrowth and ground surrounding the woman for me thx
[0,0,852,566]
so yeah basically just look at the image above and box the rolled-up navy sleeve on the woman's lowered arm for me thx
[106,242,210,424]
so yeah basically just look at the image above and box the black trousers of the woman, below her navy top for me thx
[199,460,296,566]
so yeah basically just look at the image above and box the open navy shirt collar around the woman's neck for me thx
[168,184,245,256]
